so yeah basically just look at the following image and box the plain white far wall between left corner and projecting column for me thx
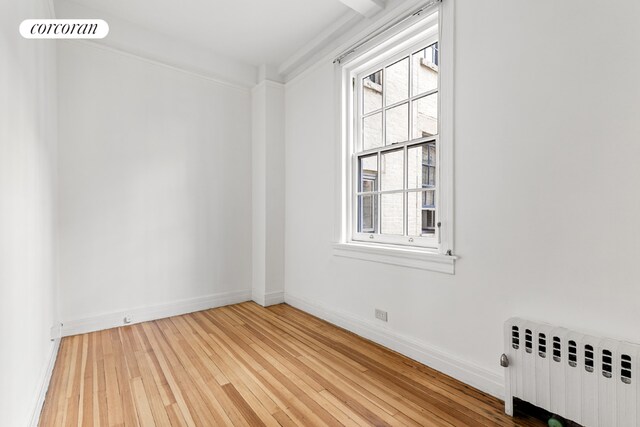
[58,42,251,331]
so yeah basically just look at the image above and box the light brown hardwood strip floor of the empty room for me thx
[40,303,544,427]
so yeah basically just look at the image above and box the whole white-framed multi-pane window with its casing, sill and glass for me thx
[334,0,455,273]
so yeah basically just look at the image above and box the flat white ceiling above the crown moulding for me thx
[65,0,354,66]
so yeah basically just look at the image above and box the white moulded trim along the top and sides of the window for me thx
[334,0,454,260]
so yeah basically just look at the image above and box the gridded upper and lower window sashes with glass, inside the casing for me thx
[352,39,439,248]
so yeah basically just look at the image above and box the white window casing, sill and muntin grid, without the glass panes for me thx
[334,0,456,274]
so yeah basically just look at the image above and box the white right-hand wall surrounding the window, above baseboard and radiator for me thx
[285,0,640,394]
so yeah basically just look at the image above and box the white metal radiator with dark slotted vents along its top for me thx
[501,318,640,427]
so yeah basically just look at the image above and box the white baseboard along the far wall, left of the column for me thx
[62,289,251,337]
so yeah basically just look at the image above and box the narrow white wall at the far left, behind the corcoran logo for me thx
[0,0,56,426]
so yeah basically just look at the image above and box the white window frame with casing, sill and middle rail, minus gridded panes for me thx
[334,0,456,274]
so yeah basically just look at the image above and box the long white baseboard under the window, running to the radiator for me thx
[284,292,504,399]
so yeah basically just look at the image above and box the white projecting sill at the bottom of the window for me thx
[333,242,457,274]
